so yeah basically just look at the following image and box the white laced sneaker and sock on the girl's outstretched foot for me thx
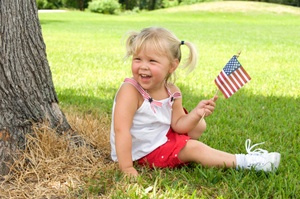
[245,139,280,171]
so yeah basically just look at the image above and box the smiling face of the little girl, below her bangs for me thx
[132,49,177,91]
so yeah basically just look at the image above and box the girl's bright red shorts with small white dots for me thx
[137,128,190,168]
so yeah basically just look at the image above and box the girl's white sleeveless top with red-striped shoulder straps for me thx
[110,78,181,161]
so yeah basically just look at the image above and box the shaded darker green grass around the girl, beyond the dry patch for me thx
[58,82,300,198]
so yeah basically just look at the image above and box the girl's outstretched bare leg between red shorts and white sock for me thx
[178,139,236,168]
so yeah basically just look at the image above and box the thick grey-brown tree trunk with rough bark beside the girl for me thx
[0,0,70,175]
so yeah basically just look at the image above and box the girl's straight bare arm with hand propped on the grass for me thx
[114,84,140,176]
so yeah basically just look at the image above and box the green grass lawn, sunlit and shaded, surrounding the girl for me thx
[39,3,300,198]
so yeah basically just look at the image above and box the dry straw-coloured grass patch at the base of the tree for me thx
[0,112,115,198]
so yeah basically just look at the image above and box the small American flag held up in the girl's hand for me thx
[215,55,251,98]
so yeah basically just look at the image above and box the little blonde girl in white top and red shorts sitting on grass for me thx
[110,27,280,176]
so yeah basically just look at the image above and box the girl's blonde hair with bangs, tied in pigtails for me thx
[126,27,197,81]
